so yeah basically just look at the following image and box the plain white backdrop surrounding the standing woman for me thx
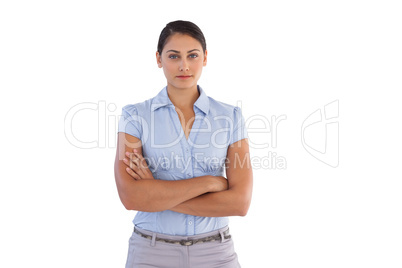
[0,0,402,268]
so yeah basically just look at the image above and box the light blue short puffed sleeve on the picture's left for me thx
[118,105,142,139]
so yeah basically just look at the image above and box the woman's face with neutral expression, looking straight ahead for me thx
[156,33,207,89]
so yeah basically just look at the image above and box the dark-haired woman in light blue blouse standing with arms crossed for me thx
[115,21,252,268]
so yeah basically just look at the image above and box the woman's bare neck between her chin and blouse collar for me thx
[167,85,200,110]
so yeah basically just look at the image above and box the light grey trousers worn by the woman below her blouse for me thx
[126,227,240,268]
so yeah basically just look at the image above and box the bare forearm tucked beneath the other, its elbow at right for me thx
[170,189,251,217]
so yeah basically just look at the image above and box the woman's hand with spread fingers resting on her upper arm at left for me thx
[123,149,155,180]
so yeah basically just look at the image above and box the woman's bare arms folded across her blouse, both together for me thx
[115,133,253,217]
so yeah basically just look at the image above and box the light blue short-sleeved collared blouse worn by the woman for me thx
[118,86,248,235]
